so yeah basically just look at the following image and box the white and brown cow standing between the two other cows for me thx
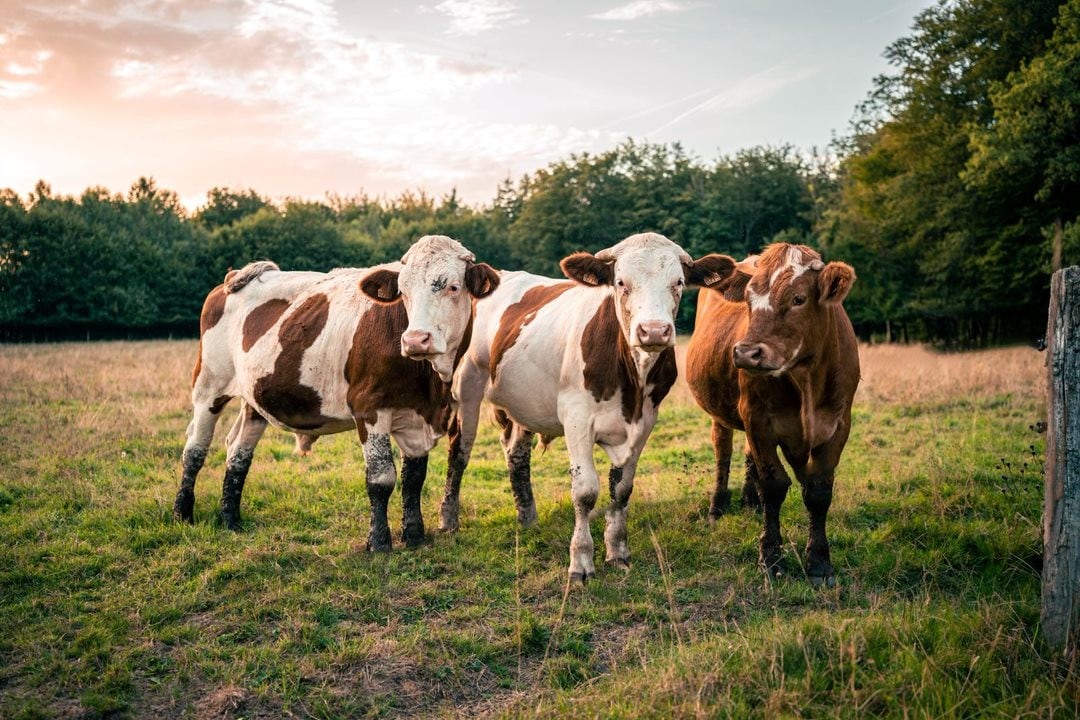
[441,233,734,583]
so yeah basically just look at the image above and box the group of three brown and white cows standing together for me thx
[174,233,859,585]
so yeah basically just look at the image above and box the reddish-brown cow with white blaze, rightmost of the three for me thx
[686,244,859,585]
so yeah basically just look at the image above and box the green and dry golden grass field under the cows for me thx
[0,341,1080,718]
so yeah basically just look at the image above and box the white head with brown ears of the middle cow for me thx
[561,232,734,353]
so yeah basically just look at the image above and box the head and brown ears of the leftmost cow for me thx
[360,235,499,382]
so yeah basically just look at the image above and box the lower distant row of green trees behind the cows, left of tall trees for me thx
[0,141,813,339]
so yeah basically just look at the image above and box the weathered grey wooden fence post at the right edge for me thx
[1042,266,1080,655]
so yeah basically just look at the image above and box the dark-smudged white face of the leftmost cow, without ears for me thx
[397,235,472,382]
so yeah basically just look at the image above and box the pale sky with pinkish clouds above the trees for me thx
[0,0,931,208]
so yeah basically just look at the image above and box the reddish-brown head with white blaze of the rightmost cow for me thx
[718,243,855,376]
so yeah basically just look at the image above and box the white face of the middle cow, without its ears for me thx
[613,243,686,352]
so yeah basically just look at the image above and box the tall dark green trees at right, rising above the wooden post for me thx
[819,0,1080,343]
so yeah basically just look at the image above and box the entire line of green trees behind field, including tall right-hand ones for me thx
[0,0,1080,344]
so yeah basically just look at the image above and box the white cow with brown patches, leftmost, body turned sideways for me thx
[174,235,499,551]
